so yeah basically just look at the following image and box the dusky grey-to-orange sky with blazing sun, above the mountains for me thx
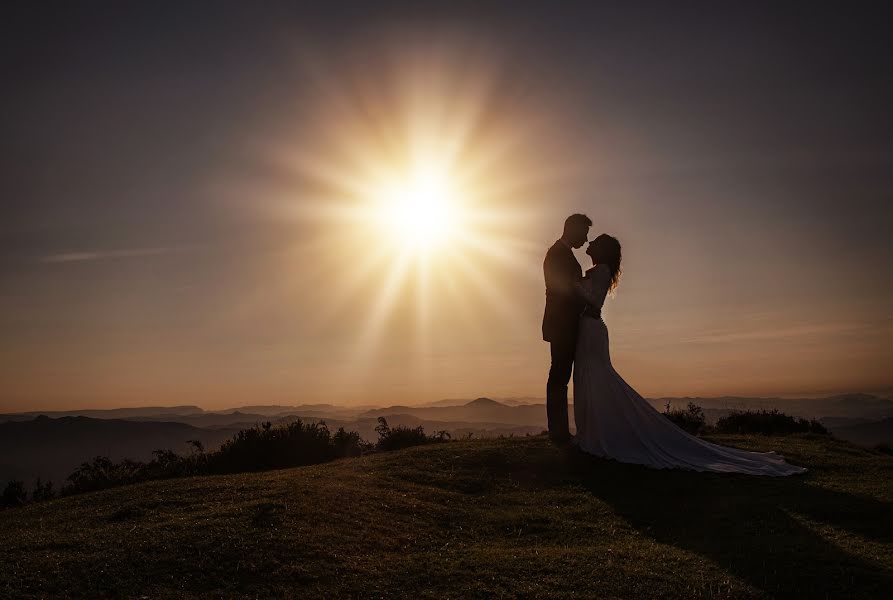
[0,2,893,411]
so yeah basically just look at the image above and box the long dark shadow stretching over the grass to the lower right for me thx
[569,454,893,598]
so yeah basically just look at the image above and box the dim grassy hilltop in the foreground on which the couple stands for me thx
[0,435,893,598]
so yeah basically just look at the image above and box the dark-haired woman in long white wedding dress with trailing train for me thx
[574,234,806,476]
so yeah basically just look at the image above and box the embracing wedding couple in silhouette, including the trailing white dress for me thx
[543,214,806,476]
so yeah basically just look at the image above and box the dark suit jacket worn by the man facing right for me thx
[543,240,586,342]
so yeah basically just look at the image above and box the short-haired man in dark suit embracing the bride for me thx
[543,214,592,444]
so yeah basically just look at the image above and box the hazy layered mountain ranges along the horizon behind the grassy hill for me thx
[0,394,893,485]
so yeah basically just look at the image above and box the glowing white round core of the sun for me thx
[373,159,462,251]
